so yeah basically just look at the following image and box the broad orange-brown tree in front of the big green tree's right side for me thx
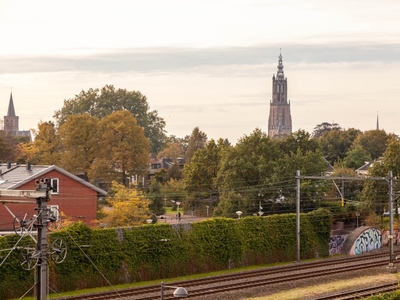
[89,110,150,185]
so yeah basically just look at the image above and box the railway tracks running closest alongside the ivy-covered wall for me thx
[54,253,398,300]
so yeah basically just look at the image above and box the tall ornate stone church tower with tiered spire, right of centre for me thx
[268,53,292,138]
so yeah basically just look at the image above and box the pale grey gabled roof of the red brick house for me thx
[0,164,107,196]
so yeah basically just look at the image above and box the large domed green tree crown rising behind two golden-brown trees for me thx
[54,85,166,153]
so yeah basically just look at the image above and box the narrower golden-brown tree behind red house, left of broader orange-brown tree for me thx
[59,114,100,180]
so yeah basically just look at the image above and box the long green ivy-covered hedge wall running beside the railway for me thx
[0,209,331,299]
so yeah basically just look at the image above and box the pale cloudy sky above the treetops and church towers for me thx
[0,0,400,144]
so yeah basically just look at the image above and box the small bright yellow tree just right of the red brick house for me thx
[101,181,150,227]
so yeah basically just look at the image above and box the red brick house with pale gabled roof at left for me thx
[0,164,107,230]
